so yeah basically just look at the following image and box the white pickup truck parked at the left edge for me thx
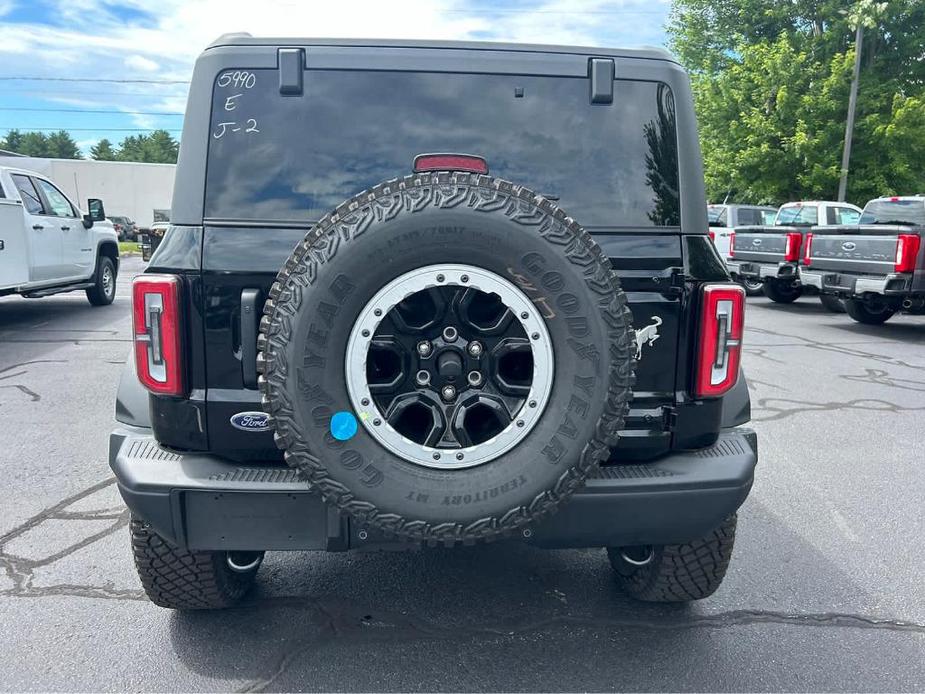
[0,167,119,306]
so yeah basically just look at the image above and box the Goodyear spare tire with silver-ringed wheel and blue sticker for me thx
[258,172,635,544]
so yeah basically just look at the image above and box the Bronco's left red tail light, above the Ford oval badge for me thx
[132,275,186,395]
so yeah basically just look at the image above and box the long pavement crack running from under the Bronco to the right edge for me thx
[237,598,925,692]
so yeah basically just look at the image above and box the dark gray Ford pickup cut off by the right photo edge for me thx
[800,196,925,325]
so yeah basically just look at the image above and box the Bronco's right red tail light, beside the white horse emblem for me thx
[694,284,745,398]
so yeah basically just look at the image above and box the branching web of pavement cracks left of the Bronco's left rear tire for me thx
[0,477,147,600]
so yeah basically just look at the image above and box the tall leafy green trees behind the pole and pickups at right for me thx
[668,0,925,204]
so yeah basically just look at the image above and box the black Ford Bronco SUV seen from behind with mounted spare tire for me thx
[110,35,757,608]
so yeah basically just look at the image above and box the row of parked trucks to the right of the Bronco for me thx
[709,195,925,324]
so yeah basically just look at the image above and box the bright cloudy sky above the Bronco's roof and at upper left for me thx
[0,0,669,142]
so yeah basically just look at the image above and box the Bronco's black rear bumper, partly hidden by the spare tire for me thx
[109,426,758,551]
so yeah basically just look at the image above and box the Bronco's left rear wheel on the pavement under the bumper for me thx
[130,517,263,610]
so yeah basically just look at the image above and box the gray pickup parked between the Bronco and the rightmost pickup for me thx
[726,201,861,311]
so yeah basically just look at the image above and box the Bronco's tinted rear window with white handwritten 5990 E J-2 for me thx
[205,70,680,227]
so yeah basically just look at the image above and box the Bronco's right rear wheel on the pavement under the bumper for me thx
[607,514,736,602]
